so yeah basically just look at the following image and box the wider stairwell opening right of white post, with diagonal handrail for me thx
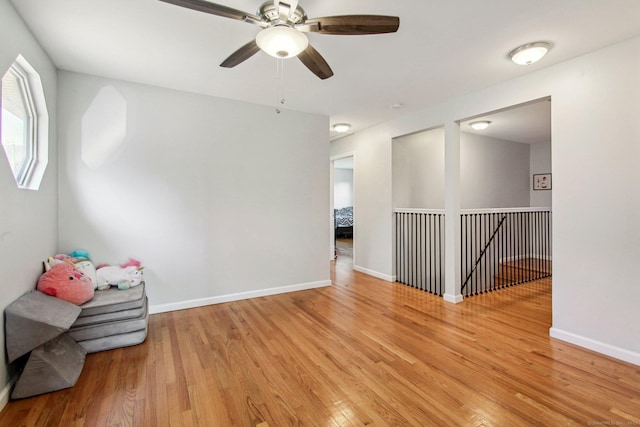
[460,97,553,296]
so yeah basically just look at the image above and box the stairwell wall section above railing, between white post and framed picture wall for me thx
[460,132,529,209]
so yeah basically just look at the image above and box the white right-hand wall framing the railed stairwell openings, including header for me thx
[331,38,640,364]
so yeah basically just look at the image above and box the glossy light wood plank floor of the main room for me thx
[0,261,640,427]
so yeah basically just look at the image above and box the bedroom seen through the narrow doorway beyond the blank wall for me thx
[331,156,354,265]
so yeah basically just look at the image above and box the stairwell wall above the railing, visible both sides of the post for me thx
[393,129,530,209]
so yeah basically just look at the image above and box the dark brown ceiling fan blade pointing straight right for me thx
[301,15,400,35]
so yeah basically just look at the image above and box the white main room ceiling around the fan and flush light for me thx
[11,0,640,140]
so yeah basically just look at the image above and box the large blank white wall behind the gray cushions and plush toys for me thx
[59,72,330,311]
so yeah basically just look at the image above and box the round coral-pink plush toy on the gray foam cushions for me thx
[37,262,94,305]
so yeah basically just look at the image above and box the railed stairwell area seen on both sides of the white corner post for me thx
[393,97,553,296]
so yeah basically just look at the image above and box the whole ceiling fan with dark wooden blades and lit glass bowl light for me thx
[160,0,400,79]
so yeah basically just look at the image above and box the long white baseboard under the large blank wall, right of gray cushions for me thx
[149,280,331,314]
